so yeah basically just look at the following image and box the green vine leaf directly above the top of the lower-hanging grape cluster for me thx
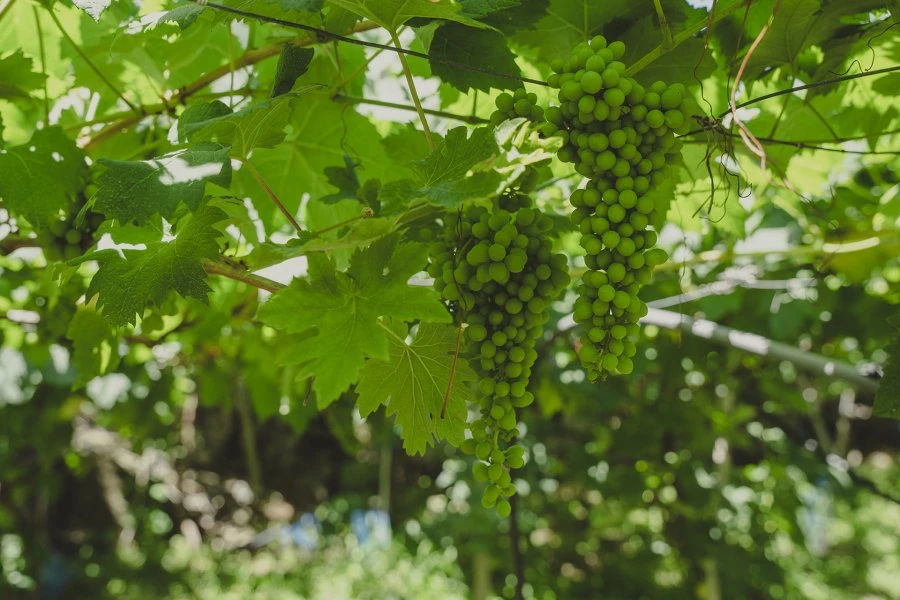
[381,127,503,208]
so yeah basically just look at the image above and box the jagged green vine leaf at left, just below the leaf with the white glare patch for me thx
[81,205,226,327]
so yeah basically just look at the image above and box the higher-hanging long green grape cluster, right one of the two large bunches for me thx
[541,36,693,379]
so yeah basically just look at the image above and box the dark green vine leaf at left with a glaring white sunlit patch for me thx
[94,142,231,223]
